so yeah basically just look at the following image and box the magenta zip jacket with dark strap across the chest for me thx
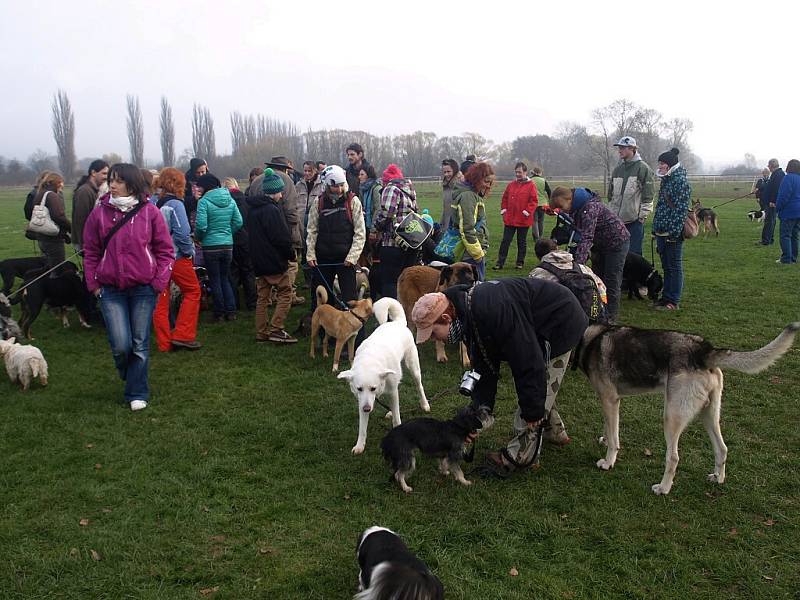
[83,195,175,293]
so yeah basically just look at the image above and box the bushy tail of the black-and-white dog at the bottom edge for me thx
[353,561,444,600]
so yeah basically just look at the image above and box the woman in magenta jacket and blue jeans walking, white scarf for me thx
[83,164,175,410]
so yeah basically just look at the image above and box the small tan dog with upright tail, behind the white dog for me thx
[310,285,372,373]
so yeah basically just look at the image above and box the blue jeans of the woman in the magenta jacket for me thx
[100,285,157,402]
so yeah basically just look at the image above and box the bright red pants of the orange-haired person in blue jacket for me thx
[153,258,200,352]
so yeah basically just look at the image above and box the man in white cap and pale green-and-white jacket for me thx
[608,135,653,255]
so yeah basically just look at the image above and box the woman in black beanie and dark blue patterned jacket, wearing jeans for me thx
[653,148,692,310]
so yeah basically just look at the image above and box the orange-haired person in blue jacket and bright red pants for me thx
[153,167,201,352]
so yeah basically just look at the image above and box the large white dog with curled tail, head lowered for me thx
[339,298,431,454]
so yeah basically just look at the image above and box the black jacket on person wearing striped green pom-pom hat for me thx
[245,196,295,277]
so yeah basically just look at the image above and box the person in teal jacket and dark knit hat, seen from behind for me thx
[195,173,242,322]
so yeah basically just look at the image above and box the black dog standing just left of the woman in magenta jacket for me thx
[13,262,92,339]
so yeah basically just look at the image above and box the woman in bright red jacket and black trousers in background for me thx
[494,162,539,270]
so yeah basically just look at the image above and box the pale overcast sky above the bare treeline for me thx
[0,0,800,171]
